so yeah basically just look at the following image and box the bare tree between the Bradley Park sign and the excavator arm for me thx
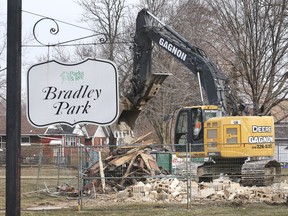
[76,0,133,92]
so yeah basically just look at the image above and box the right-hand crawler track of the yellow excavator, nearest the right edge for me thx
[241,160,281,186]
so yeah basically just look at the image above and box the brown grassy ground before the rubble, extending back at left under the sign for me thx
[0,167,288,216]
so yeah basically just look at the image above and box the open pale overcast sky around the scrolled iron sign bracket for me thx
[0,0,138,91]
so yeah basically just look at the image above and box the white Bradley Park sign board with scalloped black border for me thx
[27,59,119,127]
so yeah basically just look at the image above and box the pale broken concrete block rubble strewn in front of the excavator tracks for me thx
[116,178,288,203]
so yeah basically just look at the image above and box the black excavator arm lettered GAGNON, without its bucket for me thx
[129,9,237,115]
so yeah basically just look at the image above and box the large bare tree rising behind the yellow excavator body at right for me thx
[208,0,288,119]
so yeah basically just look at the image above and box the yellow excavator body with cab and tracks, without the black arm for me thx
[175,106,281,186]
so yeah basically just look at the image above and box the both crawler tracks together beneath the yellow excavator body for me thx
[178,158,281,186]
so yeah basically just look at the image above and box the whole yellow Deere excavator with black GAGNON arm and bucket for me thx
[118,9,281,185]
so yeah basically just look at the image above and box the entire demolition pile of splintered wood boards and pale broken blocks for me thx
[83,145,288,203]
